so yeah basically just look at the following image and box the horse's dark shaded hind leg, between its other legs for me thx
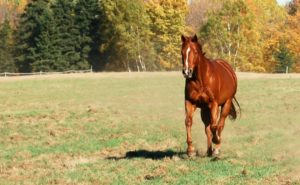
[201,106,213,156]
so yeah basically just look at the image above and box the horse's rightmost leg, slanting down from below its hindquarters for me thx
[213,99,231,154]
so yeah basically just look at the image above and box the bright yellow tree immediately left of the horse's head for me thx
[146,0,188,70]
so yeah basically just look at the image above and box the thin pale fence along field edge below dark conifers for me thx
[0,68,93,77]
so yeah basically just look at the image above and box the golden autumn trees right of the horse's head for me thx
[188,0,300,72]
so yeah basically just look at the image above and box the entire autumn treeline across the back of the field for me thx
[0,0,300,72]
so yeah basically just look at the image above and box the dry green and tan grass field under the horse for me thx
[0,72,300,185]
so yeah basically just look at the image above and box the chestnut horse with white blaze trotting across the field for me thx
[181,35,240,156]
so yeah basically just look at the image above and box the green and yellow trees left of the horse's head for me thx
[0,0,187,72]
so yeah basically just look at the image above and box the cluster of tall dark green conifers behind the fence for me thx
[15,0,105,72]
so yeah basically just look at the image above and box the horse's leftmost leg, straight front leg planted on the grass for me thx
[185,100,196,156]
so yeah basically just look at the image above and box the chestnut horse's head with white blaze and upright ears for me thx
[181,35,201,78]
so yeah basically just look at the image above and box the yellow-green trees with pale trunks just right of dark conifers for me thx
[100,0,156,71]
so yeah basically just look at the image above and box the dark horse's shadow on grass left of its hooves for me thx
[106,150,186,160]
